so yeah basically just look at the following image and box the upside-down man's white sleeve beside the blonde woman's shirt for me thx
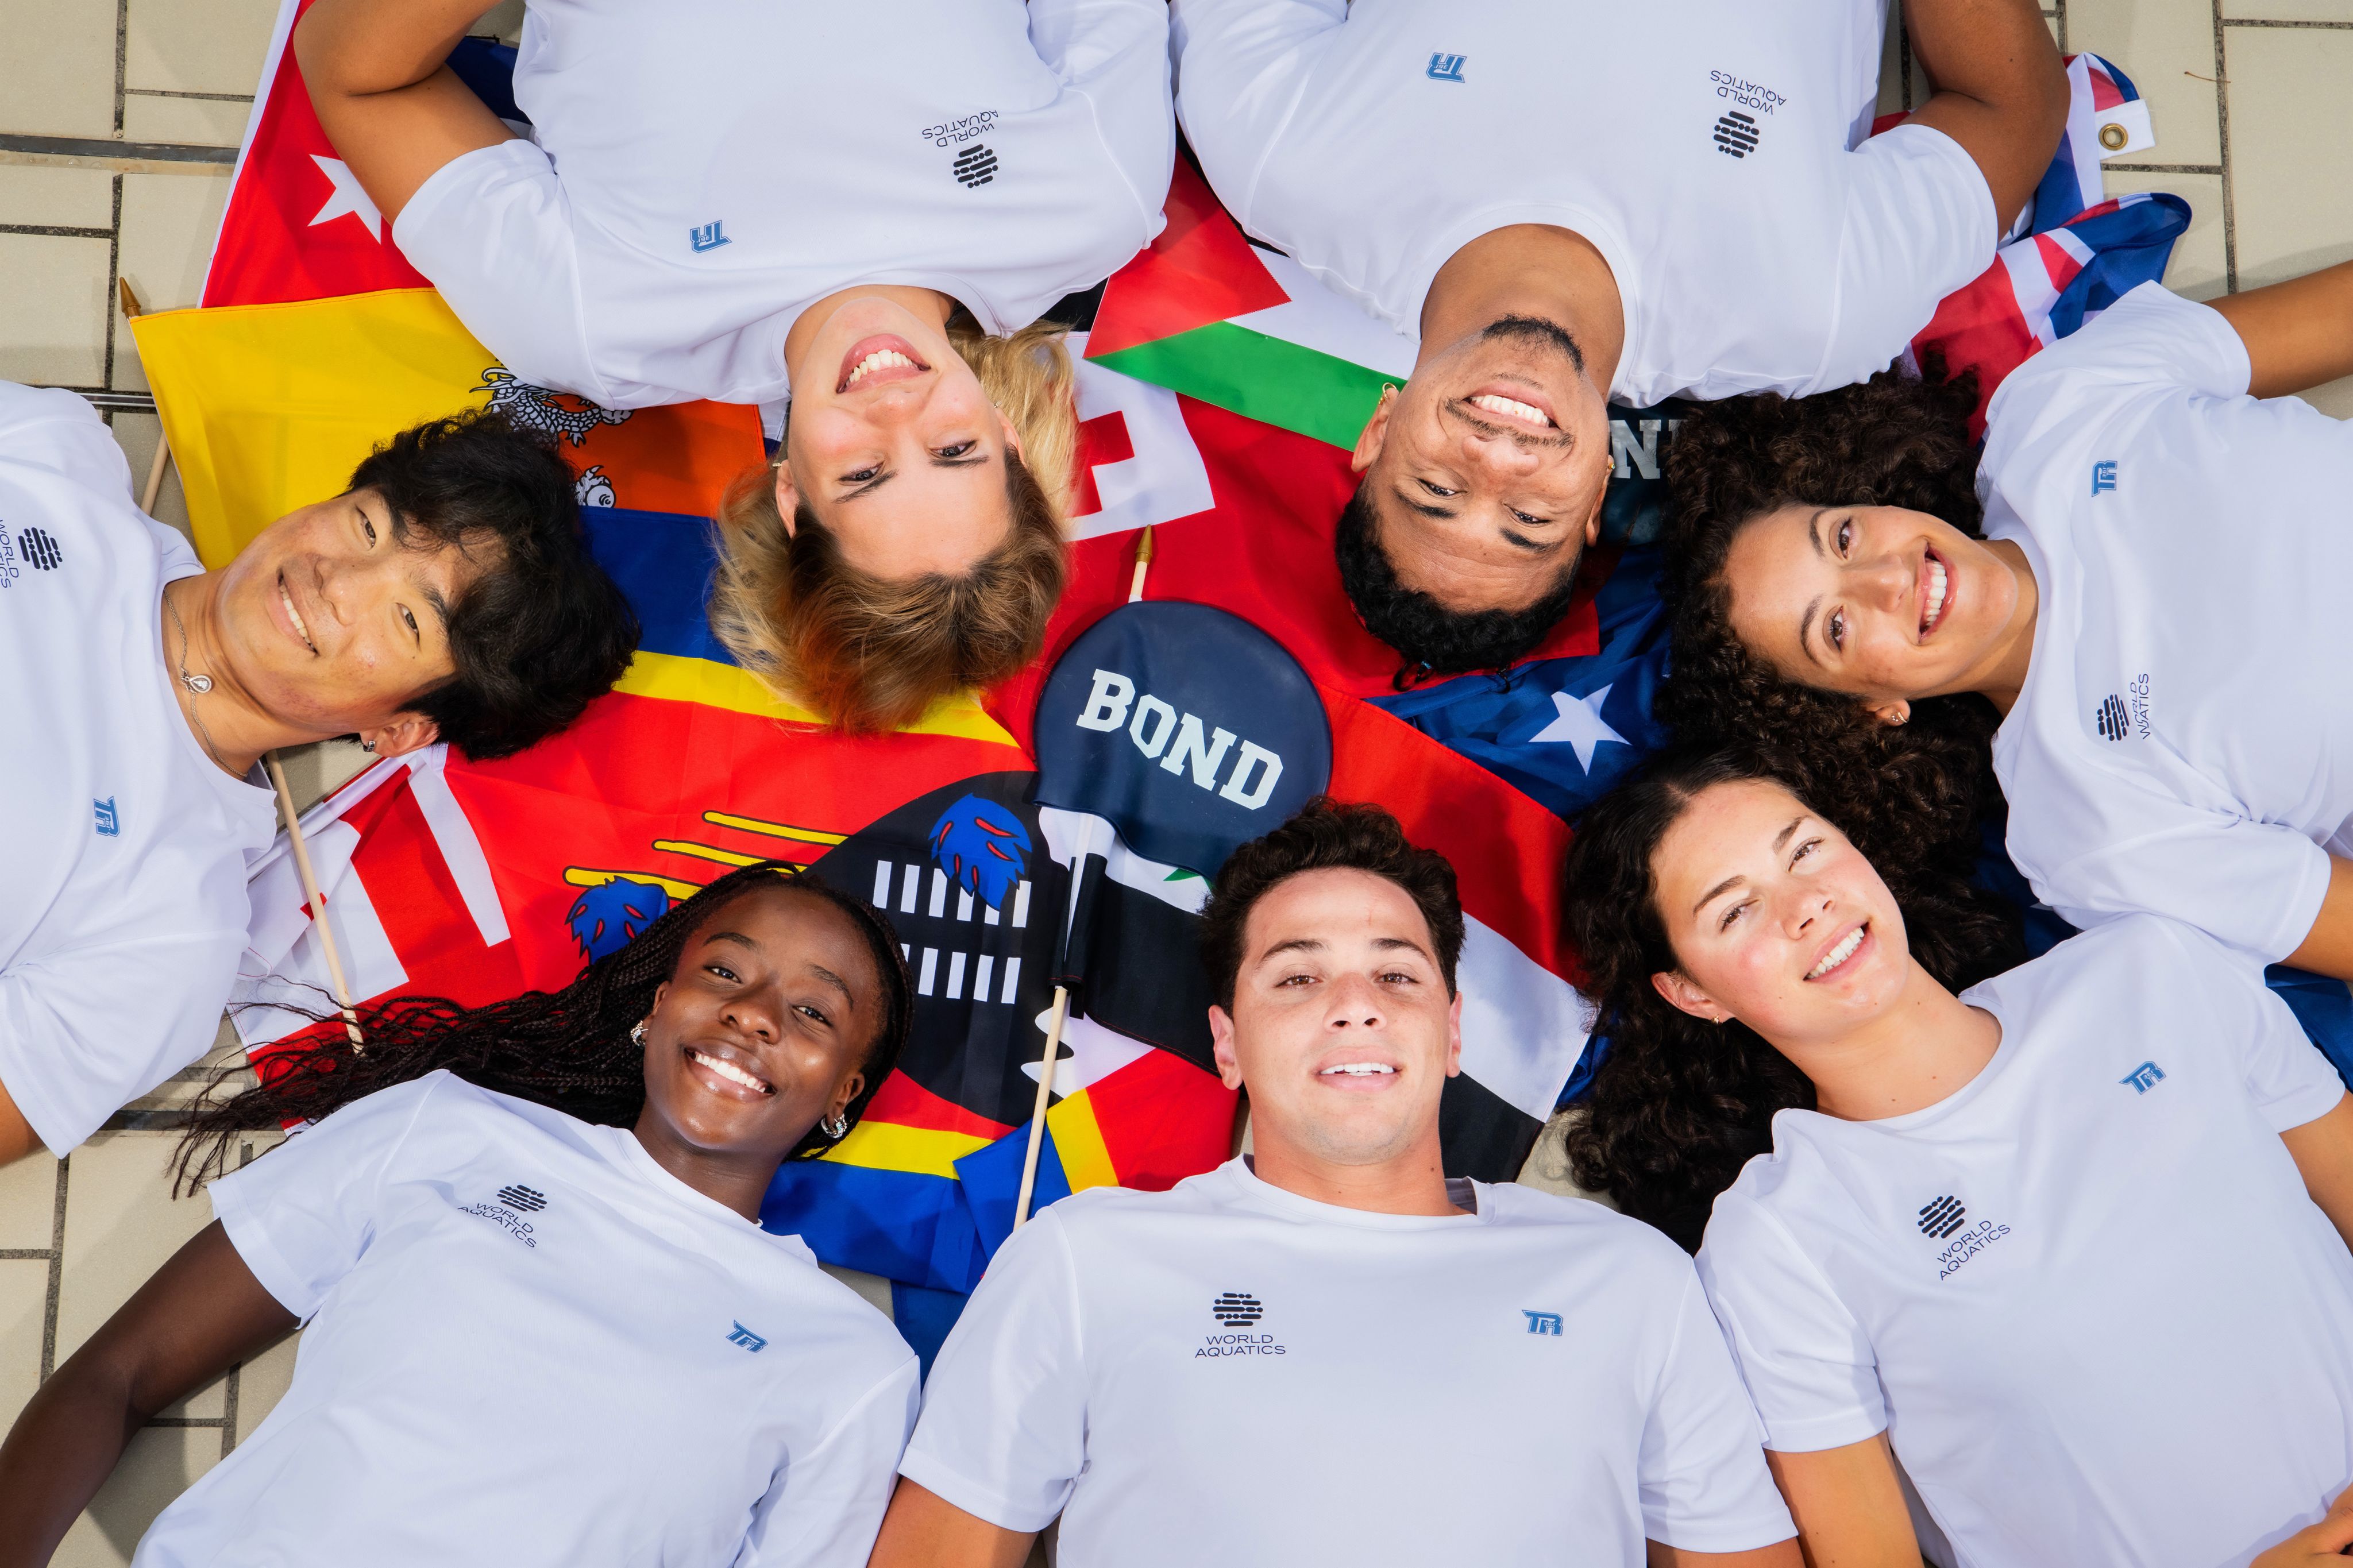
[1170,0,1348,230]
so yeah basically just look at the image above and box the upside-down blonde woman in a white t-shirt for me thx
[294,0,1176,729]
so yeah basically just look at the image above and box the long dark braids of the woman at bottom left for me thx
[174,860,915,1194]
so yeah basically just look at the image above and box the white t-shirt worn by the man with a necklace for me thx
[0,381,275,1154]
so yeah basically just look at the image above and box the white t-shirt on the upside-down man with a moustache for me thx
[1172,0,2000,404]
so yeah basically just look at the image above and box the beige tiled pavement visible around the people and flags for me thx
[0,0,2353,1568]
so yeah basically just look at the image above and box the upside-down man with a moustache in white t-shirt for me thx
[1170,0,2066,675]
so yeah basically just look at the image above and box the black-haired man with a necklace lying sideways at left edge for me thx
[0,383,638,1164]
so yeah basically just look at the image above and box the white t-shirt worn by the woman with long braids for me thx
[132,1072,917,1568]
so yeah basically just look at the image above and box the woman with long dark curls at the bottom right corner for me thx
[1569,752,2353,1568]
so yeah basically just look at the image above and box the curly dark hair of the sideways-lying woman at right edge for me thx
[1657,355,2000,860]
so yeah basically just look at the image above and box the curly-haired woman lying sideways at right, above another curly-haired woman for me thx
[1664,263,2353,978]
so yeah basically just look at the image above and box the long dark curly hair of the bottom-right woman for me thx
[1567,745,2026,1250]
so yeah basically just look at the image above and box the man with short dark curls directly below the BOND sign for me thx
[873,800,1797,1568]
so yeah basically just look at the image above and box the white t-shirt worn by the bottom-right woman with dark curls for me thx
[1699,914,2353,1568]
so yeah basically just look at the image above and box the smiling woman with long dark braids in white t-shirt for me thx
[0,863,917,1568]
